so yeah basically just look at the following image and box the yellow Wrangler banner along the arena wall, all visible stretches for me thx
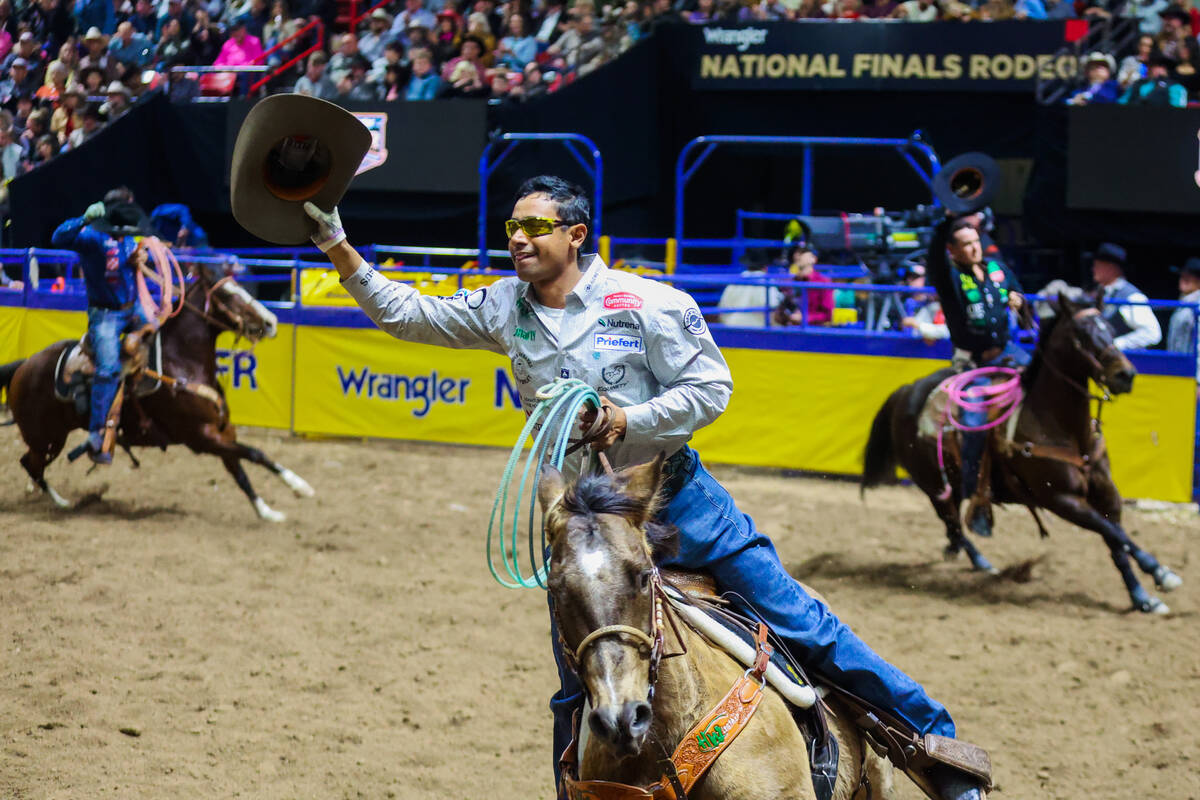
[7,307,1195,503]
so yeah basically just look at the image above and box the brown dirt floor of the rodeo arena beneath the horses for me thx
[0,428,1200,800]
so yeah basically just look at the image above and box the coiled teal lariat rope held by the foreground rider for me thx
[487,378,600,589]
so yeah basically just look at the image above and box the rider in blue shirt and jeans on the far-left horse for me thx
[52,187,150,464]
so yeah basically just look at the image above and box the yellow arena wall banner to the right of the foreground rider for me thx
[694,349,1195,503]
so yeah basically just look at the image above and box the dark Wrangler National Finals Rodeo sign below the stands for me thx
[685,20,1086,91]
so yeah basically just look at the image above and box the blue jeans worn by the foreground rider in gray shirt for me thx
[550,449,954,775]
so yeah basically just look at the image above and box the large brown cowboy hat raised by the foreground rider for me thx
[229,95,371,245]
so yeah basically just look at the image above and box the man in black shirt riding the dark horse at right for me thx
[925,217,1031,536]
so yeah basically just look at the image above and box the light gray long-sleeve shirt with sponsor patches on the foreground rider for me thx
[342,255,733,468]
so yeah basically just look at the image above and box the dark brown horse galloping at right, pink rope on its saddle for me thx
[862,297,1182,614]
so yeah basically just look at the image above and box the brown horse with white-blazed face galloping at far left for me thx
[0,267,313,522]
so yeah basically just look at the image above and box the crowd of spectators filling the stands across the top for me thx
[0,0,1200,184]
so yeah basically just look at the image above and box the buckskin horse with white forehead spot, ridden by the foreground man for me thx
[538,456,893,800]
